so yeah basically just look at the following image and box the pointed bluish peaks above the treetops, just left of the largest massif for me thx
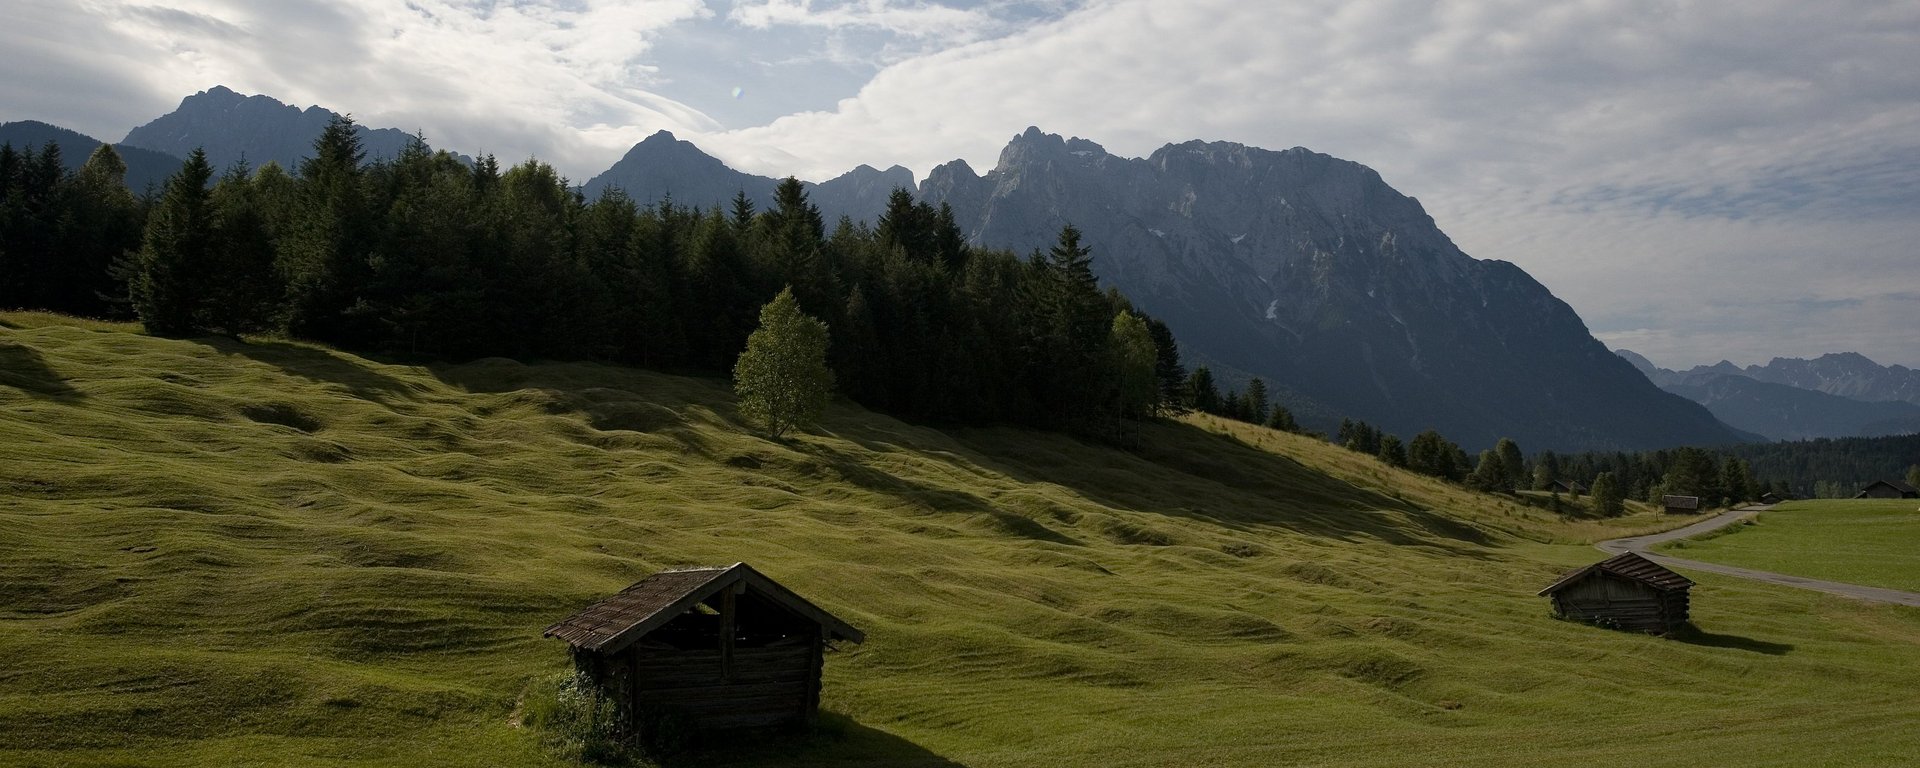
[582,131,914,230]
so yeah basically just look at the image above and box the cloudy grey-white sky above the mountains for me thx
[0,0,1920,369]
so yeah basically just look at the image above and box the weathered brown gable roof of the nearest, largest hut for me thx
[543,563,866,653]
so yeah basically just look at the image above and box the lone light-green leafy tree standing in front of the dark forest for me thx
[733,288,833,438]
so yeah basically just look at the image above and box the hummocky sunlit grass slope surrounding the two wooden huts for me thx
[0,315,1920,766]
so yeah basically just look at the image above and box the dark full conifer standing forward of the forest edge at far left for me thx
[129,148,219,336]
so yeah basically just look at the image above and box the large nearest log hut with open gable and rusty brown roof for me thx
[545,563,866,739]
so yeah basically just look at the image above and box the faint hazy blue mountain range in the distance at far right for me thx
[1615,349,1920,440]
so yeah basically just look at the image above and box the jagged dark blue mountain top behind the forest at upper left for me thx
[123,86,464,173]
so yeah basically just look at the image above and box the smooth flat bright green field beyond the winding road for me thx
[1663,499,1920,591]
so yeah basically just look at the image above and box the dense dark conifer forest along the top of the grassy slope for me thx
[0,119,1187,432]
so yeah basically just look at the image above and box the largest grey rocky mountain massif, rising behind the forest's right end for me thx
[920,129,1753,449]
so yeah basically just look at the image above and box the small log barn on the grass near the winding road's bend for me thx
[1540,553,1693,636]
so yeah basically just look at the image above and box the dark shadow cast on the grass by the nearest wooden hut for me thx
[659,712,966,768]
